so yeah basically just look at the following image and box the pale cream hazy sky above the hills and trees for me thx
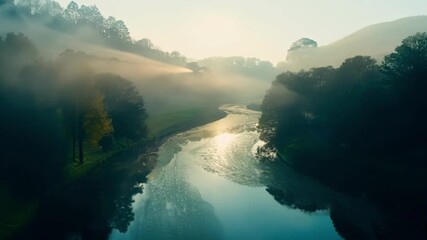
[58,0,427,63]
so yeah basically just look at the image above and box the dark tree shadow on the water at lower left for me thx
[16,152,153,239]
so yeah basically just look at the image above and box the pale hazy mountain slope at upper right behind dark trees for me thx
[283,16,427,71]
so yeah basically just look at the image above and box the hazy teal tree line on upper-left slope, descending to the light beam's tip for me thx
[7,0,187,66]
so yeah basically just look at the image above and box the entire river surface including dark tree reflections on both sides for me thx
[15,106,427,240]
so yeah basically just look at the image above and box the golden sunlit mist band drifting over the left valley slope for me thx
[0,2,272,117]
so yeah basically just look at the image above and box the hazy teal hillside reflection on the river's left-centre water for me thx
[110,126,222,240]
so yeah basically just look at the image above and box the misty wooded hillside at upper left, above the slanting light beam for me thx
[0,0,186,66]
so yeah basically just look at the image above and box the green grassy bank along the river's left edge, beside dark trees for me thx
[59,107,227,186]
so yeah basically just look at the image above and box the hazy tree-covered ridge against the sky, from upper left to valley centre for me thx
[4,0,277,76]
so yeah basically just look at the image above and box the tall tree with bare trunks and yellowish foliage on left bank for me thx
[55,50,112,163]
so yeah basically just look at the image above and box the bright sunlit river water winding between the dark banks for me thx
[110,105,348,240]
